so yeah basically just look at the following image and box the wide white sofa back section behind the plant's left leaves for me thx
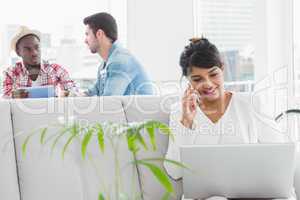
[11,97,139,200]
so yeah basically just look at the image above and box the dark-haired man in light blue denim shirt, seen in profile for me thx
[83,13,153,96]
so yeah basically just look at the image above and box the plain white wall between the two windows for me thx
[127,0,194,81]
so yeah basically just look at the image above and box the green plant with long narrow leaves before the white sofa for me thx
[22,117,187,200]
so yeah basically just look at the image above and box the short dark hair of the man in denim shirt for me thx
[83,12,118,42]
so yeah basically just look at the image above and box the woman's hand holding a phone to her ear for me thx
[181,85,200,128]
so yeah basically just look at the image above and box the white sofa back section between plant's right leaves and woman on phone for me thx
[121,95,182,200]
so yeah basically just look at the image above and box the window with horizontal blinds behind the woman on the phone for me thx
[194,0,256,91]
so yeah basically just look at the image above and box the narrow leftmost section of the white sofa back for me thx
[0,101,20,200]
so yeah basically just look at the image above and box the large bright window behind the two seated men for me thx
[0,0,127,90]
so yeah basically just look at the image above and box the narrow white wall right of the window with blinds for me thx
[254,0,293,81]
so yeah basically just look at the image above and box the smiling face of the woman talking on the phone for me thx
[188,67,224,102]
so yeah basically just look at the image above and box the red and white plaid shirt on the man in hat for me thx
[3,61,75,98]
